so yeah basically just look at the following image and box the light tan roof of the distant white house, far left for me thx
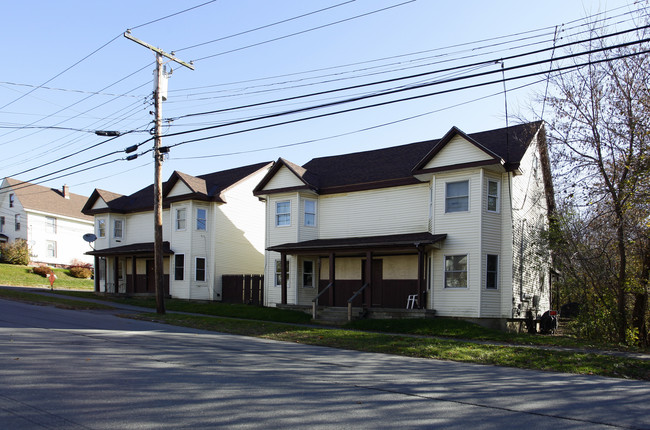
[5,178,92,221]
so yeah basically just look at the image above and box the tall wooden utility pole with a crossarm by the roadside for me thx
[124,30,194,314]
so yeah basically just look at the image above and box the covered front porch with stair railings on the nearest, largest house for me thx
[268,232,446,320]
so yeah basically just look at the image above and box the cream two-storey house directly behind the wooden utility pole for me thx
[83,162,273,300]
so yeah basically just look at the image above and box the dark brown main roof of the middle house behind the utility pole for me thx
[83,162,271,214]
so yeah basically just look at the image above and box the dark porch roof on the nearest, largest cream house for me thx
[267,232,447,254]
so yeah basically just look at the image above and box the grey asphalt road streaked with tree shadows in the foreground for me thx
[0,300,650,430]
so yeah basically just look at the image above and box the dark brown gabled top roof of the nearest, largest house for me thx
[255,121,542,195]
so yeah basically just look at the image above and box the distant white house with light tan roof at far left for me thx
[0,178,93,265]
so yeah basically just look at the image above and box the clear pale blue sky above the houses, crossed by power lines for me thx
[0,0,638,196]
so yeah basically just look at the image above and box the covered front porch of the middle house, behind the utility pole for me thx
[86,242,174,296]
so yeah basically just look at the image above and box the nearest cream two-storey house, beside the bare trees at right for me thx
[254,122,552,326]
